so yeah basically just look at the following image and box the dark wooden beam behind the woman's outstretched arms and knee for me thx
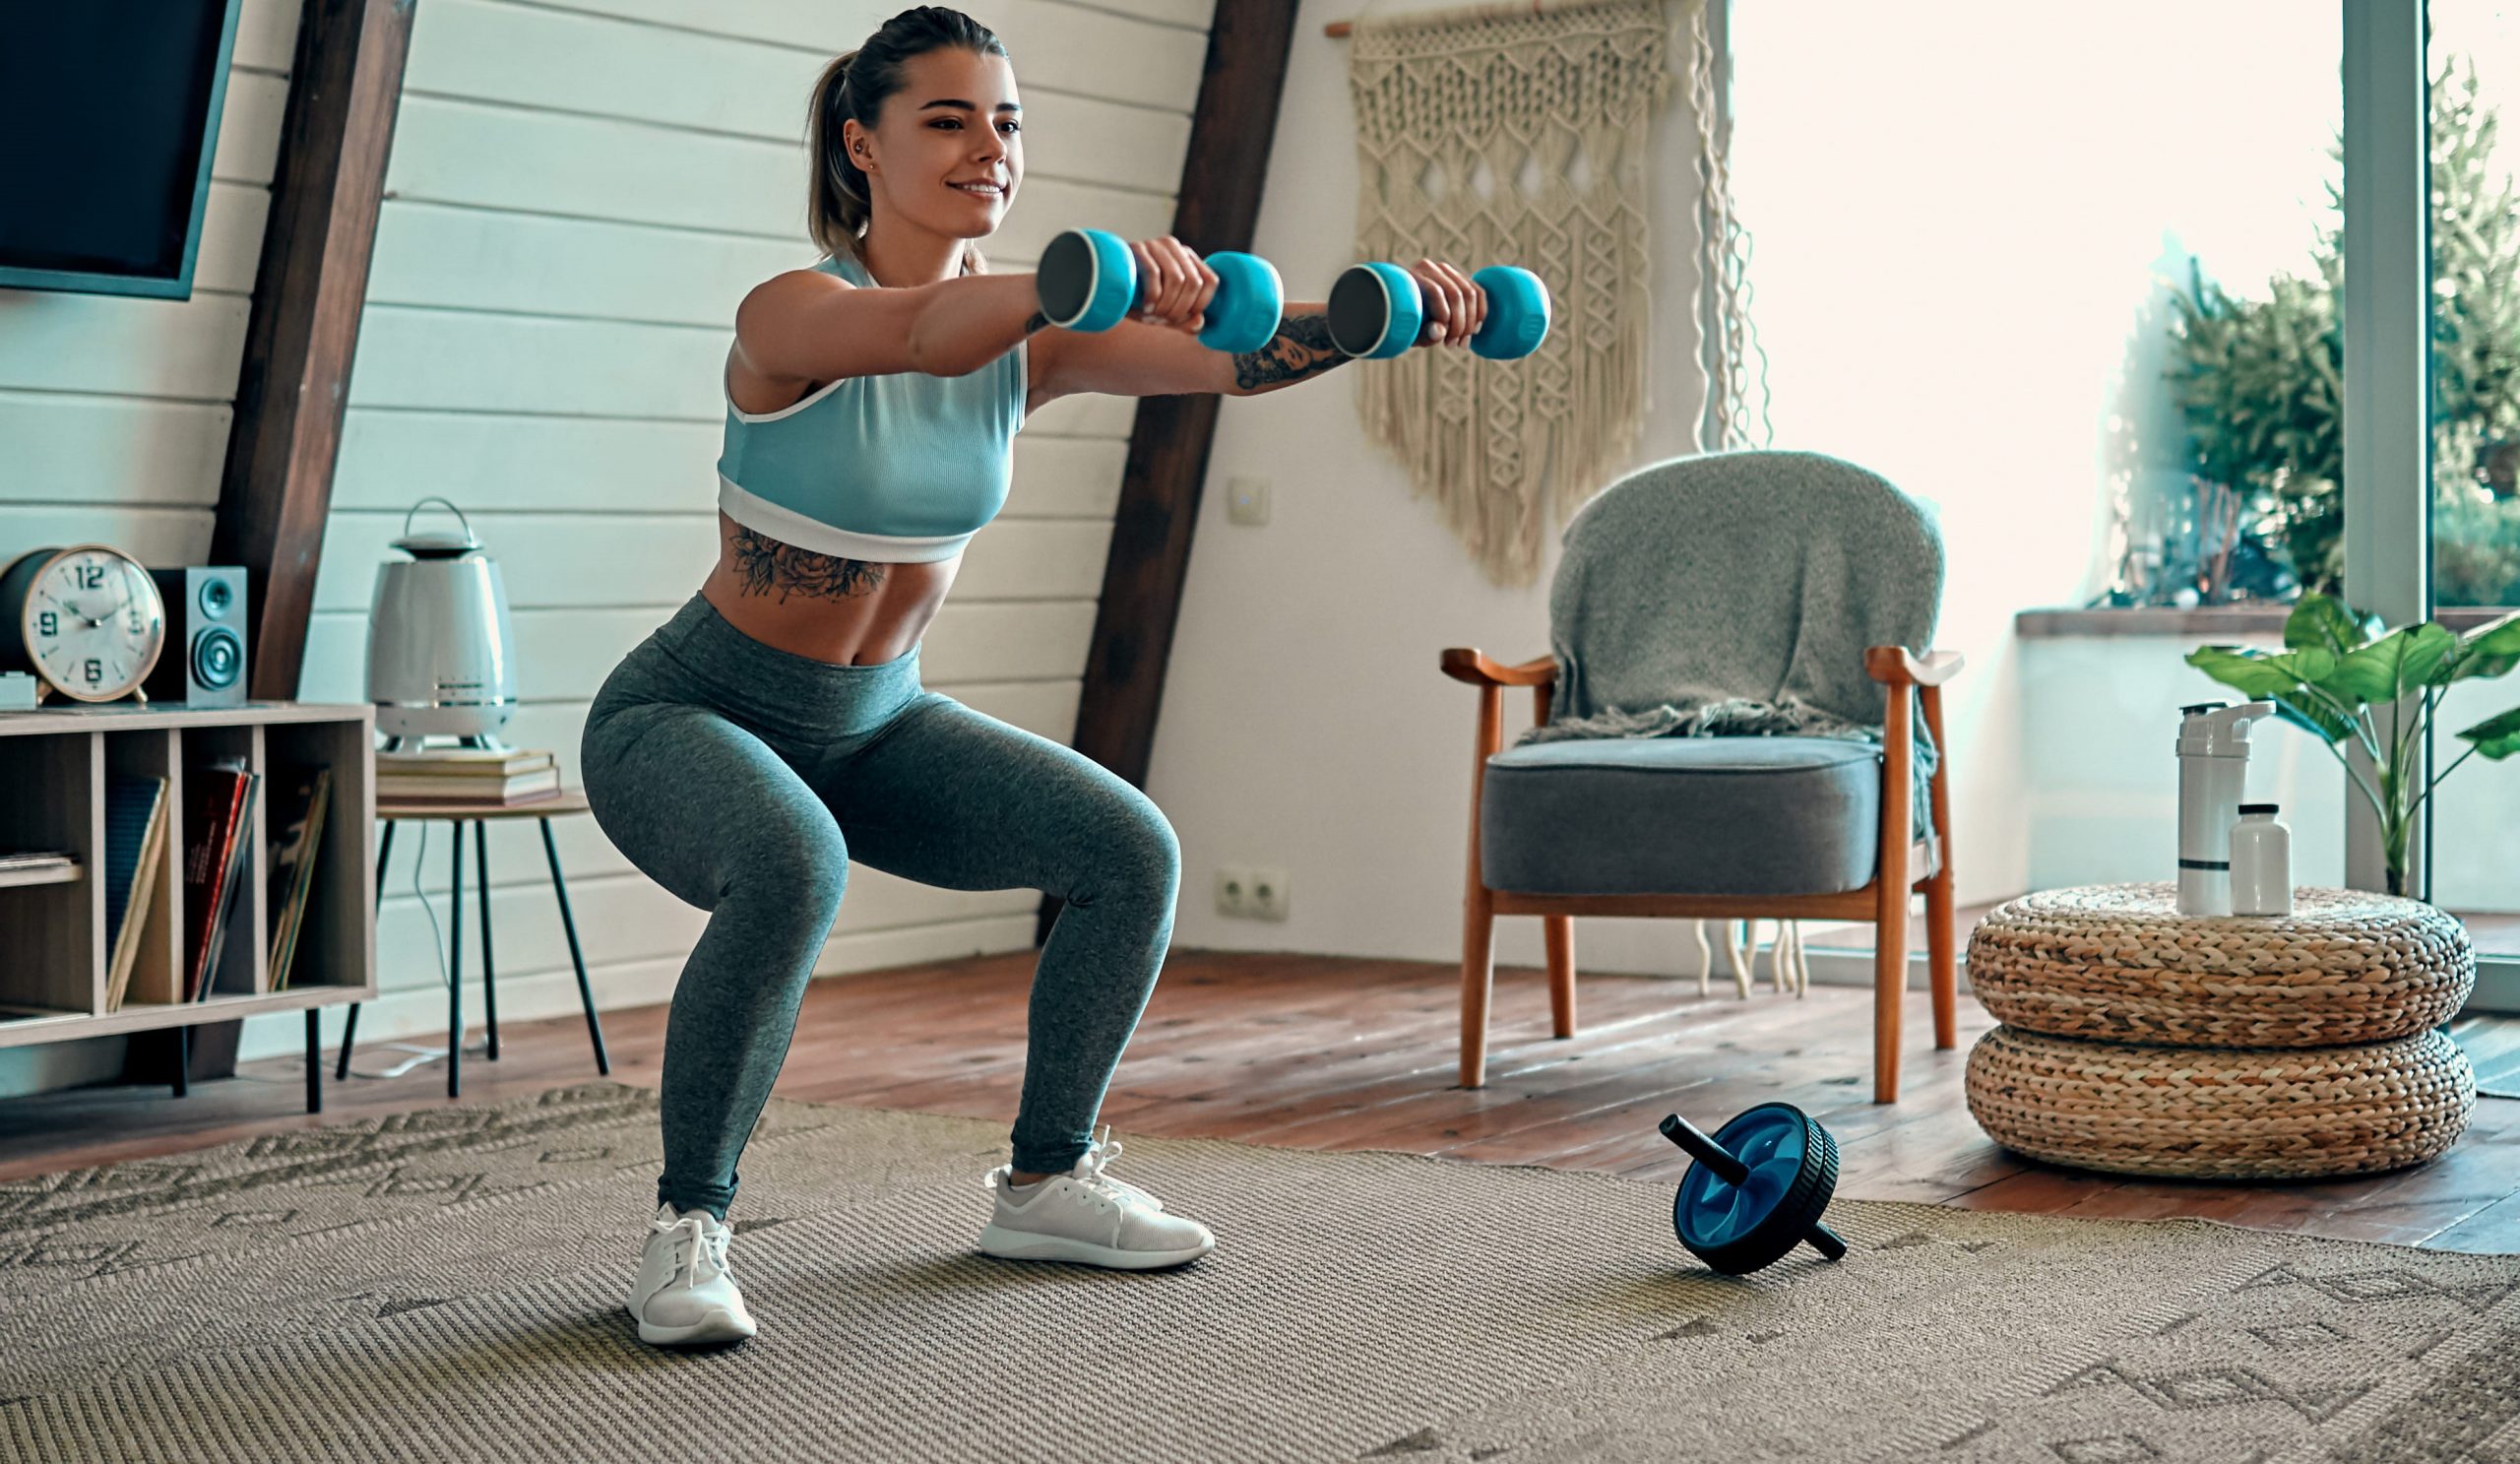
[1036,0,1295,942]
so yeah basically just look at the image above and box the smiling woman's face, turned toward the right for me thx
[842,45,1023,239]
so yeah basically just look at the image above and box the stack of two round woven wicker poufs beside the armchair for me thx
[1968,884,2477,1179]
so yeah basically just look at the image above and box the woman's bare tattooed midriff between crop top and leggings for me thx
[701,512,963,666]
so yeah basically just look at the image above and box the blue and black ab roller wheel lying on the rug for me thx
[1664,1104,1847,1275]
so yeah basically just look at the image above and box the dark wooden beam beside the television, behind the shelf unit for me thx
[209,0,413,701]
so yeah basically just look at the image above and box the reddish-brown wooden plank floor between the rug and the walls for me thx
[0,950,2520,1252]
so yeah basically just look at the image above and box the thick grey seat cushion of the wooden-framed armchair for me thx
[1480,735,1922,895]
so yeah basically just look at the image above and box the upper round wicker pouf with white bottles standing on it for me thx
[1968,884,2477,1049]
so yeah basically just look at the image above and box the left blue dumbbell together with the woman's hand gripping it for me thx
[1036,229,1286,350]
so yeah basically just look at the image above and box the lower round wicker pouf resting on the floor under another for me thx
[1968,1028,2477,1179]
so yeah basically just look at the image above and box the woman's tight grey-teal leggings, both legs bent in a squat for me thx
[580,595,1182,1220]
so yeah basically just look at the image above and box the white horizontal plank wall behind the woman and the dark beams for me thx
[0,0,1212,1091]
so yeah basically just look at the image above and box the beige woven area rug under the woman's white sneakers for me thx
[0,1084,2520,1464]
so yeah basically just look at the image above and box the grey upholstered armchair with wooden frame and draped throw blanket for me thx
[1441,451,1961,1104]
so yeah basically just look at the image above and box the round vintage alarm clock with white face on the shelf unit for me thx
[0,544,166,701]
